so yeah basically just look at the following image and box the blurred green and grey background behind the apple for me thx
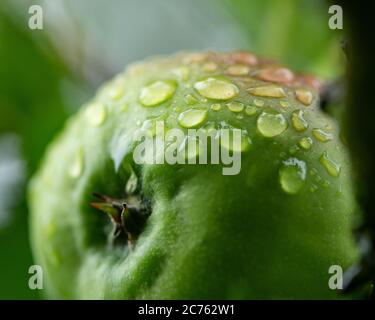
[0,0,344,299]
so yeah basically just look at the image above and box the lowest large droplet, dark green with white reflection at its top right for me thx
[279,158,306,194]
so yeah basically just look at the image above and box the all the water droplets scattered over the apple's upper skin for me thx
[69,57,341,194]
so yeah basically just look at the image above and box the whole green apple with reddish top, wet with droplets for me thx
[29,52,358,299]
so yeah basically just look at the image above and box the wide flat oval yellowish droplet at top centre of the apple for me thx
[194,77,239,100]
